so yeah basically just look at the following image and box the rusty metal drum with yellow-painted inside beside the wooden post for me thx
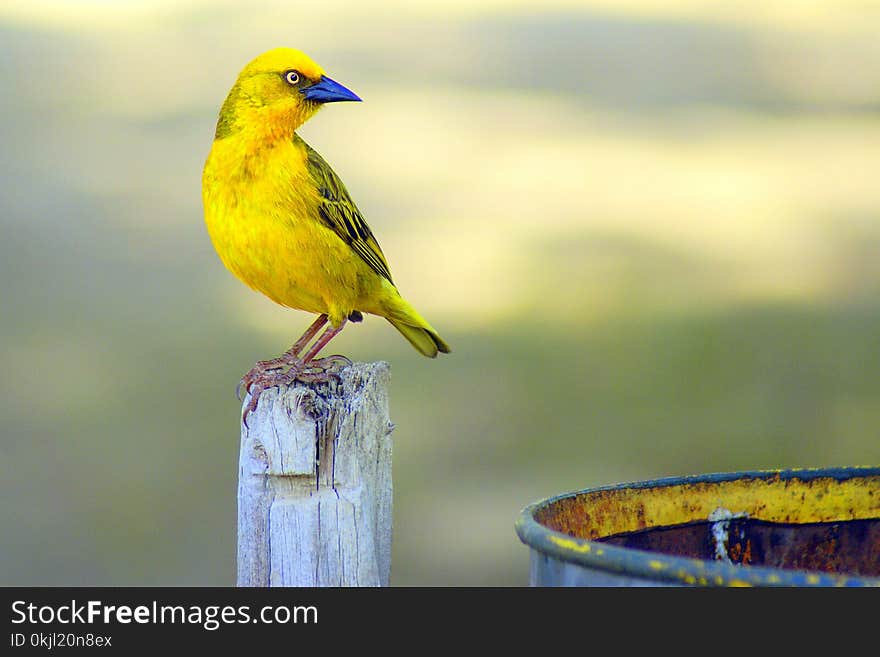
[516,467,880,586]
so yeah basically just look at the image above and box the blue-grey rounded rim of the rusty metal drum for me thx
[515,467,880,586]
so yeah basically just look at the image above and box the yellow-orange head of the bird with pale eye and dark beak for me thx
[215,48,360,139]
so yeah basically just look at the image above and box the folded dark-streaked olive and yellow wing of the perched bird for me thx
[302,141,393,283]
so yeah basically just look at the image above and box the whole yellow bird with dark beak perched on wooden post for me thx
[202,48,450,416]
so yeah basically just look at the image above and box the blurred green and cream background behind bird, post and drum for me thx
[0,0,880,585]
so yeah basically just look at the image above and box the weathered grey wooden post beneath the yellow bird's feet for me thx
[238,362,393,586]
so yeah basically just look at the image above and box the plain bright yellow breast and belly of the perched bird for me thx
[202,140,358,313]
